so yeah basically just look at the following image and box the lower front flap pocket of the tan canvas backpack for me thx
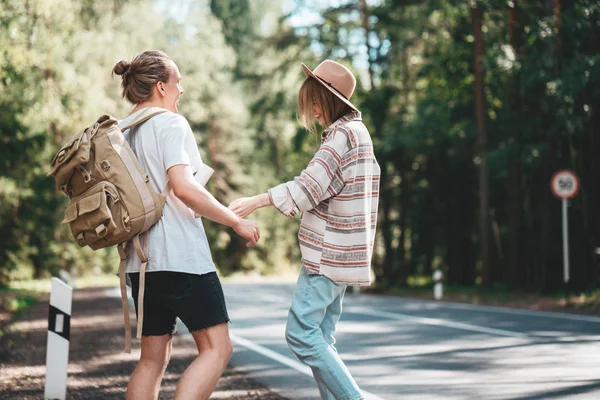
[62,181,131,249]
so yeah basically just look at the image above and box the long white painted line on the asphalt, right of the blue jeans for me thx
[344,307,528,338]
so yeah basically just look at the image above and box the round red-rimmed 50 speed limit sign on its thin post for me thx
[550,169,579,304]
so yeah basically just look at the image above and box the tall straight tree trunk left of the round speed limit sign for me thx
[471,2,492,287]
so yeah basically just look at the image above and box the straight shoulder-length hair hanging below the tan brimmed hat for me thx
[298,76,353,133]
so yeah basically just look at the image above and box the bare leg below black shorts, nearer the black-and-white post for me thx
[126,335,173,400]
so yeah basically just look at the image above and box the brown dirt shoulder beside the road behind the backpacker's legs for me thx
[0,288,285,400]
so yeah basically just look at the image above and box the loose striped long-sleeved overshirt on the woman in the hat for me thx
[269,112,381,286]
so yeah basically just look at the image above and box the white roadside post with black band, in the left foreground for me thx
[44,278,73,400]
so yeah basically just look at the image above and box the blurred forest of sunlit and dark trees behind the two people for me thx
[0,0,600,292]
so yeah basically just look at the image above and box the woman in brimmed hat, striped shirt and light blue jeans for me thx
[229,60,380,400]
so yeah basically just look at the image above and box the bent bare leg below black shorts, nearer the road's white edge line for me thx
[175,323,233,400]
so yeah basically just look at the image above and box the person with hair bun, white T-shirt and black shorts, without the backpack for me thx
[113,51,260,400]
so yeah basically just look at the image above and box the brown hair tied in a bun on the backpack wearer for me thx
[113,50,173,104]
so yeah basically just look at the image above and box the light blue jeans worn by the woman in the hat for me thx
[285,266,363,400]
